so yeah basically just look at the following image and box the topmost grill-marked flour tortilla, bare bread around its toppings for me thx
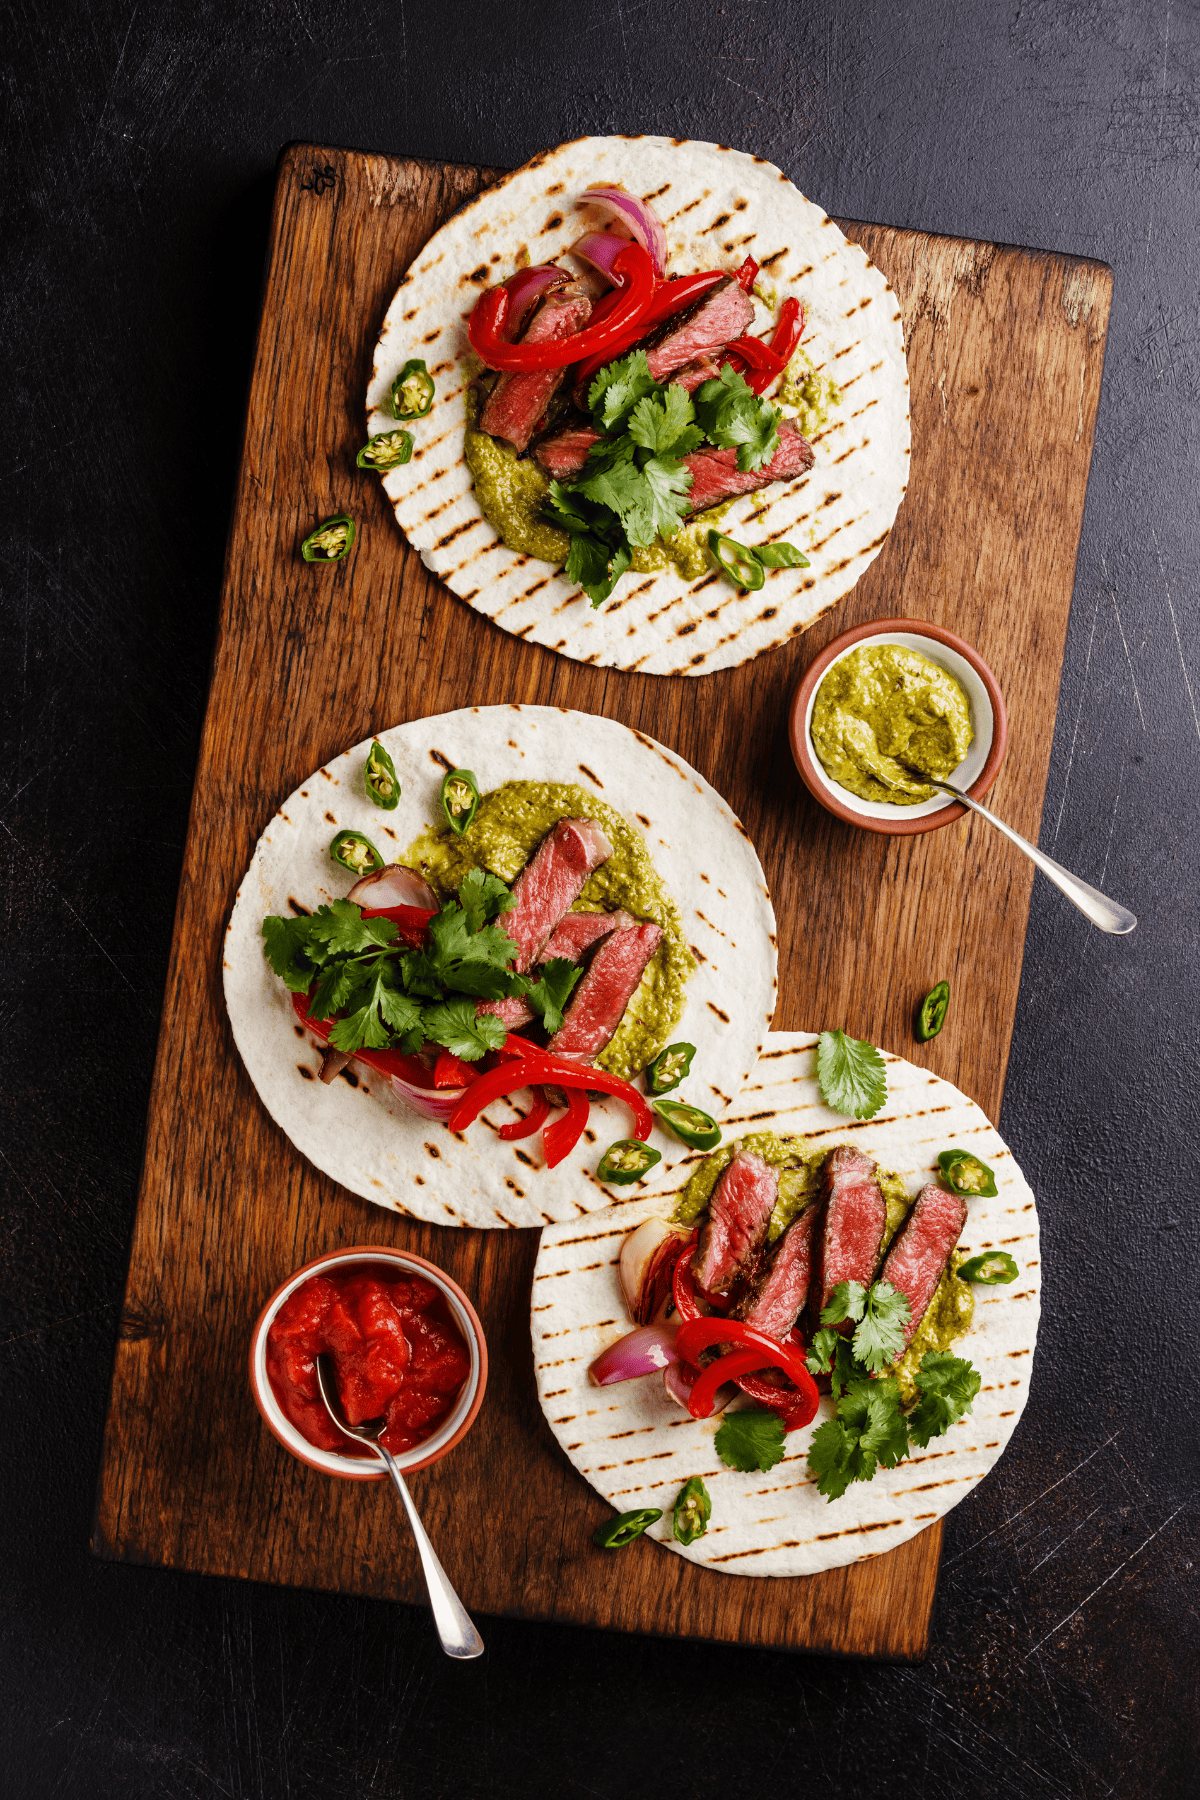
[367,137,909,675]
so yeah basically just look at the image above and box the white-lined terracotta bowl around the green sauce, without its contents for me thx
[788,619,1007,837]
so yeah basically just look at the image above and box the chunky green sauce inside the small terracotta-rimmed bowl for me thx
[810,644,975,806]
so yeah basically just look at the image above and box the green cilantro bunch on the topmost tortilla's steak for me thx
[547,349,783,607]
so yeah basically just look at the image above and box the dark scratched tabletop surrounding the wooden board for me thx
[0,0,1200,1800]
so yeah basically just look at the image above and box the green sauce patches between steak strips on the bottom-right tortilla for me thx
[671,1130,975,1375]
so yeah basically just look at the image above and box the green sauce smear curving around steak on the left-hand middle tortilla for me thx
[401,781,696,1080]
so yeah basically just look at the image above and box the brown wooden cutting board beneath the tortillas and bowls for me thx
[92,146,1112,1660]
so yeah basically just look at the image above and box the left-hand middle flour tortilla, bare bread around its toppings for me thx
[225,706,775,1228]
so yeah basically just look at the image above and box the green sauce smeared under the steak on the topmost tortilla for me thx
[462,389,732,581]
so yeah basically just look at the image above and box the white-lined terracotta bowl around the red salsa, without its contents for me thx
[250,1244,488,1481]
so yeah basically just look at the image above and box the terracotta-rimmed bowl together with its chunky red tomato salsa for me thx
[250,1251,488,1476]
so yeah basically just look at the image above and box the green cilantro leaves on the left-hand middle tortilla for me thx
[263,869,539,1062]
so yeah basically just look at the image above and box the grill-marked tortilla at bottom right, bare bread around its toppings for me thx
[531,1031,1042,1575]
